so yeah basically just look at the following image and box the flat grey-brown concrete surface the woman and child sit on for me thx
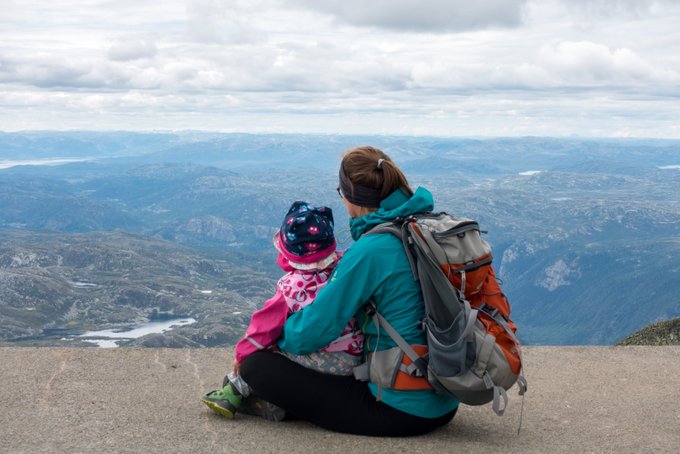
[0,347,680,454]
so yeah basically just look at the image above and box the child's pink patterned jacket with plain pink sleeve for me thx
[236,253,363,363]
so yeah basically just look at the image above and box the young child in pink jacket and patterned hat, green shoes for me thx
[202,201,363,420]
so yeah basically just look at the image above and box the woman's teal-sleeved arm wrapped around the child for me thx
[279,241,389,355]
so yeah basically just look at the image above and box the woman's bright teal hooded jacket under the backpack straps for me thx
[279,188,458,418]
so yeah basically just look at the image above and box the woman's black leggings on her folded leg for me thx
[240,351,456,436]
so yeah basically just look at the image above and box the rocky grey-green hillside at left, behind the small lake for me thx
[0,231,273,347]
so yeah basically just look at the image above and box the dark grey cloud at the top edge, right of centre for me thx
[292,0,527,32]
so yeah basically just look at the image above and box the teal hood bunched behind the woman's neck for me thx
[349,187,434,241]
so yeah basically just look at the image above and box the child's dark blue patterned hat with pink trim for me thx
[278,201,336,263]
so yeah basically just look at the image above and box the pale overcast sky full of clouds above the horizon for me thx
[0,0,680,138]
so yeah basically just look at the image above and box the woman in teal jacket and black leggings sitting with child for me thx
[240,147,458,436]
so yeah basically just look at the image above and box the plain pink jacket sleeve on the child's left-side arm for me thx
[236,287,289,363]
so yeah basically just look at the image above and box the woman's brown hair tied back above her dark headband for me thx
[340,146,413,199]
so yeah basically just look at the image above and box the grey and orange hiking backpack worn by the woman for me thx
[355,213,526,416]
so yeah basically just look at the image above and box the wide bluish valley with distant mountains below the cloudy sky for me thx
[0,132,680,346]
